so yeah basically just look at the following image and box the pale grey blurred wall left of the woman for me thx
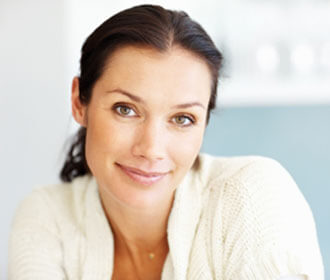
[0,0,70,279]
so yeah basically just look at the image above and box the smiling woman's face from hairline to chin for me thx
[73,46,212,208]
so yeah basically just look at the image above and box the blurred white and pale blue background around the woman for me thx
[0,0,330,279]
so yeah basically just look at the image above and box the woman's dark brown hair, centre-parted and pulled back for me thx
[60,5,222,182]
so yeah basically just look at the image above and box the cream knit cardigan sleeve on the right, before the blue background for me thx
[222,157,324,280]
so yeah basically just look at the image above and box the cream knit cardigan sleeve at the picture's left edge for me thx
[8,190,66,280]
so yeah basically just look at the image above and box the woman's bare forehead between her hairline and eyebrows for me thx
[94,46,212,103]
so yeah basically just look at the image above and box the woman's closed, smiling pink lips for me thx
[116,163,169,186]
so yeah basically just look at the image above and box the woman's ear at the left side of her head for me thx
[71,77,87,127]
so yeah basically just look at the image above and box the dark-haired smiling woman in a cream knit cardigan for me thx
[9,5,323,280]
